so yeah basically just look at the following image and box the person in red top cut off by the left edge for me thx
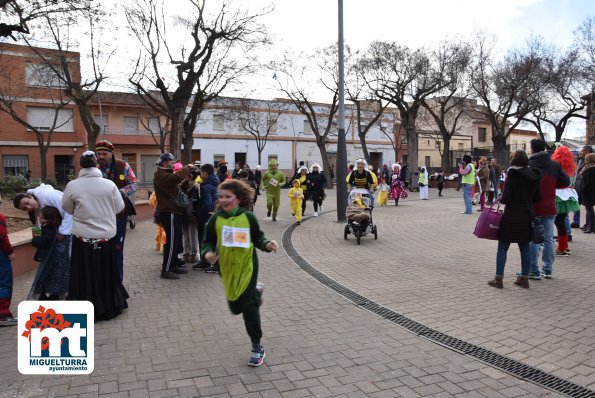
[0,199,18,326]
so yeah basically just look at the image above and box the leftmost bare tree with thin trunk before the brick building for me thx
[0,57,74,181]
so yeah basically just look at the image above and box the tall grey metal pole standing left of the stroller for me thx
[335,0,347,222]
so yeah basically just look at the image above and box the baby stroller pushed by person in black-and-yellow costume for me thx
[343,188,378,245]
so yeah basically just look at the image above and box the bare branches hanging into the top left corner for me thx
[0,0,91,41]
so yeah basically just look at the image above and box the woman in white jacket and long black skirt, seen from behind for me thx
[62,151,128,320]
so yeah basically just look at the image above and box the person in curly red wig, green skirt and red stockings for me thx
[552,143,580,256]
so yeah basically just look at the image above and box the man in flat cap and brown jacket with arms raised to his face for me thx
[153,153,194,279]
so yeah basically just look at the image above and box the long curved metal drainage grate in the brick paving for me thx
[282,219,595,398]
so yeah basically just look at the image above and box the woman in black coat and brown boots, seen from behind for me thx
[488,150,541,289]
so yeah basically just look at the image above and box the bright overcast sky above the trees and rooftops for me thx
[104,0,595,135]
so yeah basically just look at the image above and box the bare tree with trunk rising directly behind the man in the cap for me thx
[21,4,113,150]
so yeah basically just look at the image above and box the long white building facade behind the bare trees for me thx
[193,99,396,172]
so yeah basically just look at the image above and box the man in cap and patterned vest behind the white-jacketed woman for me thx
[95,140,138,283]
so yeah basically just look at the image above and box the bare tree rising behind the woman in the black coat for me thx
[471,35,549,165]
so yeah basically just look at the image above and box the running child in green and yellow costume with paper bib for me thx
[201,180,279,366]
